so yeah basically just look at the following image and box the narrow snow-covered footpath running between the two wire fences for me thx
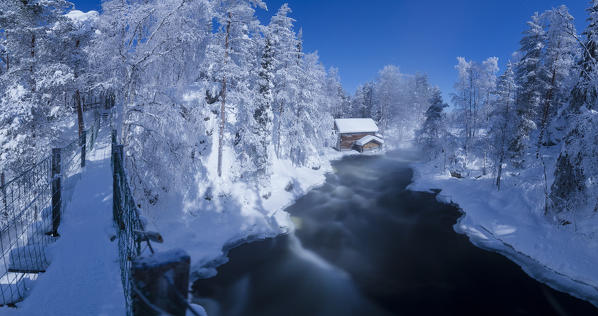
[0,129,125,315]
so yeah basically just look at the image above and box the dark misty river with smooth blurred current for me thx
[193,152,598,316]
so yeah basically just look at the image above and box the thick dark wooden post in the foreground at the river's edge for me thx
[131,250,191,316]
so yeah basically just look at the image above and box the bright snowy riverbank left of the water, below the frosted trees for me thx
[143,148,370,279]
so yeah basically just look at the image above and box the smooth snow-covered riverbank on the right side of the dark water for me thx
[409,163,598,306]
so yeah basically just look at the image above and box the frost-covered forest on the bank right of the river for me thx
[417,0,598,224]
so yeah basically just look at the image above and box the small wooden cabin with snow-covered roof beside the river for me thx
[334,118,384,152]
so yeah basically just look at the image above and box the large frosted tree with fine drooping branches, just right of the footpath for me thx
[95,0,219,203]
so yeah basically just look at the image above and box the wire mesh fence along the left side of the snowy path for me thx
[0,112,100,305]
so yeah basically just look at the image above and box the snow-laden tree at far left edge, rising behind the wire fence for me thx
[0,0,79,172]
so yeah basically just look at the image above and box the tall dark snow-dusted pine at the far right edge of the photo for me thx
[548,0,598,220]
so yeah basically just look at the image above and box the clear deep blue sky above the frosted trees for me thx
[71,0,589,97]
